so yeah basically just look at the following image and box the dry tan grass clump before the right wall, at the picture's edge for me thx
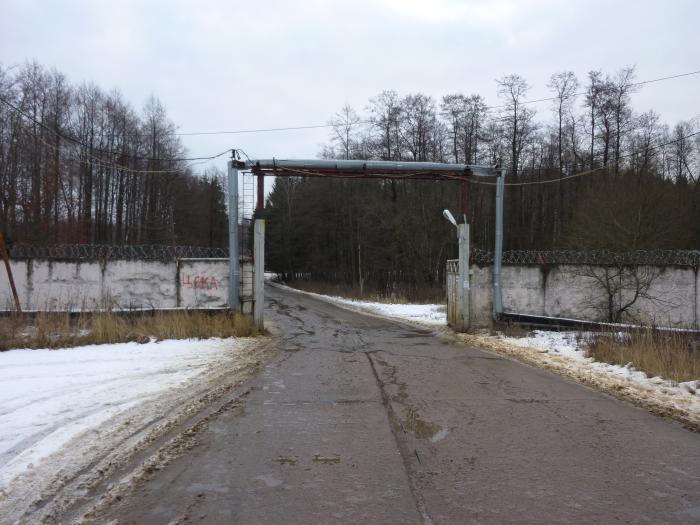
[587,329,700,382]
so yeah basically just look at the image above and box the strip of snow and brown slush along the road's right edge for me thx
[276,284,700,431]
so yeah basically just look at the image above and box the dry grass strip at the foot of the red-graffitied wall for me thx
[0,310,258,350]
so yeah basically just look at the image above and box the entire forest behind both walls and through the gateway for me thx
[0,62,700,298]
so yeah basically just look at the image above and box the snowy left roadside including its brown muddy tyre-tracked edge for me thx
[0,338,270,521]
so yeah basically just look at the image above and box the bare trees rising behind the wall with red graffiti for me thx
[0,63,227,246]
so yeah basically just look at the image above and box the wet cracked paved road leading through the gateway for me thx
[108,287,700,524]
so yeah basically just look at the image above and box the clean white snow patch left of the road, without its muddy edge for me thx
[0,339,235,489]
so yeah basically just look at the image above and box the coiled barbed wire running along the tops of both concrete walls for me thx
[10,243,700,268]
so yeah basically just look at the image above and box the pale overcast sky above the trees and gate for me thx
[0,0,700,170]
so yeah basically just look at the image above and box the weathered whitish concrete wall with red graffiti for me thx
[0,259,253,312]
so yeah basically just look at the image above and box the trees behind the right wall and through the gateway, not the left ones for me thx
[266,68,700,296]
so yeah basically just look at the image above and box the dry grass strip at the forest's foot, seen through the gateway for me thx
[287,280,445,304]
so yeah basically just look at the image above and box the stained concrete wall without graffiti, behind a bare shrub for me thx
[470,265,700,328]
